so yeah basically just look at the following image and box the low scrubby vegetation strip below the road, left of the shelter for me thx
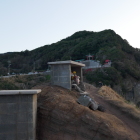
[0,74,50,90]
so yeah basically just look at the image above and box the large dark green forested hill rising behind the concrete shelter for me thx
[0,30,140,103]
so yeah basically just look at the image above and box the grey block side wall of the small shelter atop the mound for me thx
[51,64,71,89]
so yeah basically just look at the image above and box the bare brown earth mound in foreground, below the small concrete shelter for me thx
[37,86,135,140]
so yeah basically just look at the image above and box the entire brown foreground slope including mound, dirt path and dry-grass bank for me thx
[35,84,140,140]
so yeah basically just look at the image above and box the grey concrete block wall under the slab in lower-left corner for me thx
[0,94,37,140]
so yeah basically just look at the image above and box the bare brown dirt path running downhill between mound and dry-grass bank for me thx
[85,83,140,140]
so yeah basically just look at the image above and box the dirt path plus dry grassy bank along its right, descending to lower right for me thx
[85,83,140,140]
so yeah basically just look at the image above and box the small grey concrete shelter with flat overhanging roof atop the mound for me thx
[48,61,85,90]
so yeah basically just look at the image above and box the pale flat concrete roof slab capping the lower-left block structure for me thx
[0,89,41,95]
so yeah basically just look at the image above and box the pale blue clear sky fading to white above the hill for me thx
[0,0,140,53]
